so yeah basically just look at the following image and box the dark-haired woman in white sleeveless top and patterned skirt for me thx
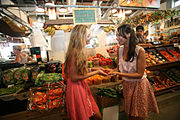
[110,24,159,120]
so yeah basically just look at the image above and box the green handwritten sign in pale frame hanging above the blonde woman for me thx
[73,8,97,24]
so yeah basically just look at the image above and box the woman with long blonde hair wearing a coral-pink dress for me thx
[64,25,107,120]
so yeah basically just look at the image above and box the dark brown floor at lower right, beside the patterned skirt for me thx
[119,90,180,120]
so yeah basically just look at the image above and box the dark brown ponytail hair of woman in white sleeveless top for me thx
[117,24,137,62]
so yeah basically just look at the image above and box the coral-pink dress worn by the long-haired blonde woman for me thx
[66,66,99,120]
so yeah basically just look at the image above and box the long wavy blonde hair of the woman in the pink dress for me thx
[64,25,88,75]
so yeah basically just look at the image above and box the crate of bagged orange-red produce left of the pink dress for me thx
[28,82,65,111]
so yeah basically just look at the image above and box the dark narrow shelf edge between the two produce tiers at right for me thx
[146,60,180,71]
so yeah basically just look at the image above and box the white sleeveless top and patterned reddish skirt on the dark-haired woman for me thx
[119,45,159,117]
